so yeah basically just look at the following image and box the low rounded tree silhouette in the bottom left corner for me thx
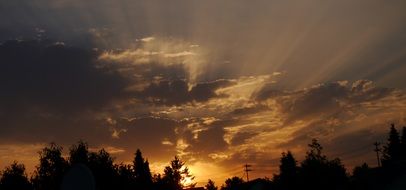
[0,161,32,190]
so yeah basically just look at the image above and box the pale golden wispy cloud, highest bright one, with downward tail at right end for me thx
[99,37,207,83]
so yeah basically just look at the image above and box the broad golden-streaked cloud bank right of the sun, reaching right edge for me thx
[176,80,406,177]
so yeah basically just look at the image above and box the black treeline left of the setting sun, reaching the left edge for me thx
[0,141,195,190]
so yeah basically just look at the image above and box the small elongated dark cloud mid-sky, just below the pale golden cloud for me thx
[136,80,234,105]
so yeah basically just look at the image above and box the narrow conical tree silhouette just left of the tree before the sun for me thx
[133,149,152,189]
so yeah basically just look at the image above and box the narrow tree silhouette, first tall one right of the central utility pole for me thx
[274,151,299,189]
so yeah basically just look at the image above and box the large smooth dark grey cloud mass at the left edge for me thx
[0,40,128,114]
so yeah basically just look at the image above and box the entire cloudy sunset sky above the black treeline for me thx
[0,0,406,184]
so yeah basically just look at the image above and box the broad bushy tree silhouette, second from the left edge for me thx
[32,143,68,190]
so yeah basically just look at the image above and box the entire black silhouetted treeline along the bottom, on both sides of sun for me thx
[0,125,406,190]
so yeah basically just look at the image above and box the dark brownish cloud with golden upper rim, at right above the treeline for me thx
[254,80,394,123]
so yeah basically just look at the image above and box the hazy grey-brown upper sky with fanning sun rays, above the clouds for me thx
[0,0,406,87]
